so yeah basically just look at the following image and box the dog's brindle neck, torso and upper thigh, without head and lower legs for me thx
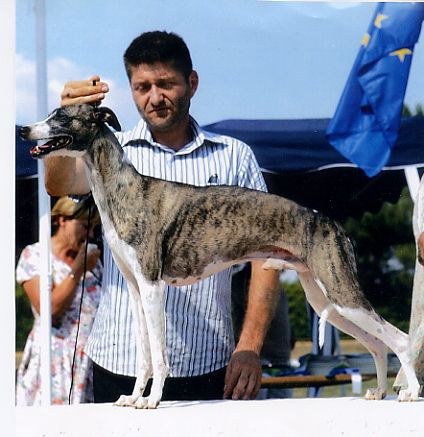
[85,124,369,307]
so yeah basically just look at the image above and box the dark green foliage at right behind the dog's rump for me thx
[344,188,416,330]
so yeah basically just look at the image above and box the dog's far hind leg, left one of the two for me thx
[298,271,387,399]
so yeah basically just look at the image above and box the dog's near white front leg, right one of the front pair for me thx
[135,276,169,408]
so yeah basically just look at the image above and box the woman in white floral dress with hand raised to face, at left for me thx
[16,197,102,405]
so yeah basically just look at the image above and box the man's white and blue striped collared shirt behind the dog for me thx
[86,119,266,377]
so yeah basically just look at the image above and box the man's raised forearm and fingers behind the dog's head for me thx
[44,75,109,196]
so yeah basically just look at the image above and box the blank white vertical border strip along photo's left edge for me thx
[0,0,15,435]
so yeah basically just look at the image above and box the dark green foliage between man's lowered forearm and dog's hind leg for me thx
[283,281,311,340]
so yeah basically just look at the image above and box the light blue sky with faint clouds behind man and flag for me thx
[16,0,424,129]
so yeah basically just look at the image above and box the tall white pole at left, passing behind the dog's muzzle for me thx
[35,0,51,406]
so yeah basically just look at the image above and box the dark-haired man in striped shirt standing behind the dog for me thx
[45,32,278,402]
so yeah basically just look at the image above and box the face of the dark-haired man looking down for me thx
[130,62,198,132]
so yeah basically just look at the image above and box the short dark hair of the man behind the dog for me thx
[124,31,193,81]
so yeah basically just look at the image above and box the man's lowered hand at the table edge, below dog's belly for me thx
[224,351,262,400]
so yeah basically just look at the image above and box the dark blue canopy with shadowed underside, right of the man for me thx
[205,116,424,220]
